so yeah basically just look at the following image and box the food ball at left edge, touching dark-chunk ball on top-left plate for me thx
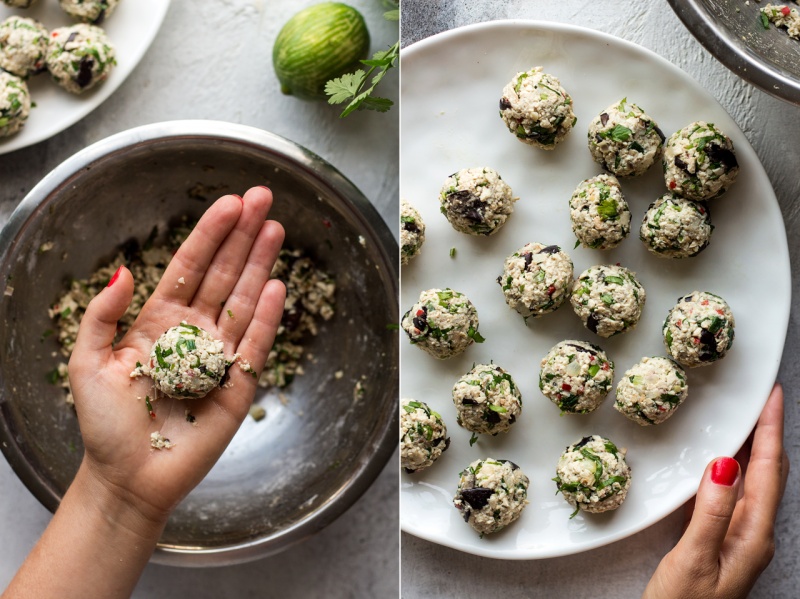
[0,15,50,79]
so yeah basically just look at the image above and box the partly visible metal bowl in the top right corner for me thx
[669,0,800,104]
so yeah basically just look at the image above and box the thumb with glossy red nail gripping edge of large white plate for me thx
[678,458,742,567]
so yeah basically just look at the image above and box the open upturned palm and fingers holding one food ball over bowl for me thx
[69,188,285,522]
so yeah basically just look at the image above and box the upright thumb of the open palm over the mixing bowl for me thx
[70,266,133,370]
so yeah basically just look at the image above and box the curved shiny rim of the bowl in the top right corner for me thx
[668,0,800,104]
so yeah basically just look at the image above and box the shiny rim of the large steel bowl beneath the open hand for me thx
[0,120,398,567]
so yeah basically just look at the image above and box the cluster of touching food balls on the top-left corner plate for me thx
[0,0,119,137]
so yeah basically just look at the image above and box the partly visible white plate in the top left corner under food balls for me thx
[0,0,170,154]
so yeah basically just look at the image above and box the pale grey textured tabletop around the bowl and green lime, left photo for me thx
[0,0,399,599]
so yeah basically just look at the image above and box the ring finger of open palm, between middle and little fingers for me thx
[217,221,284,346]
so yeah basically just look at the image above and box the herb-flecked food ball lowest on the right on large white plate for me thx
[553,435,631,518]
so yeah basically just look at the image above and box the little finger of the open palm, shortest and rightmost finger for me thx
[236,279,286,375]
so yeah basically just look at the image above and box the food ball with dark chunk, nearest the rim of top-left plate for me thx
[47,23,117,94]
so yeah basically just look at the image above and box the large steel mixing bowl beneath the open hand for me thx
[0,121,398,566]
